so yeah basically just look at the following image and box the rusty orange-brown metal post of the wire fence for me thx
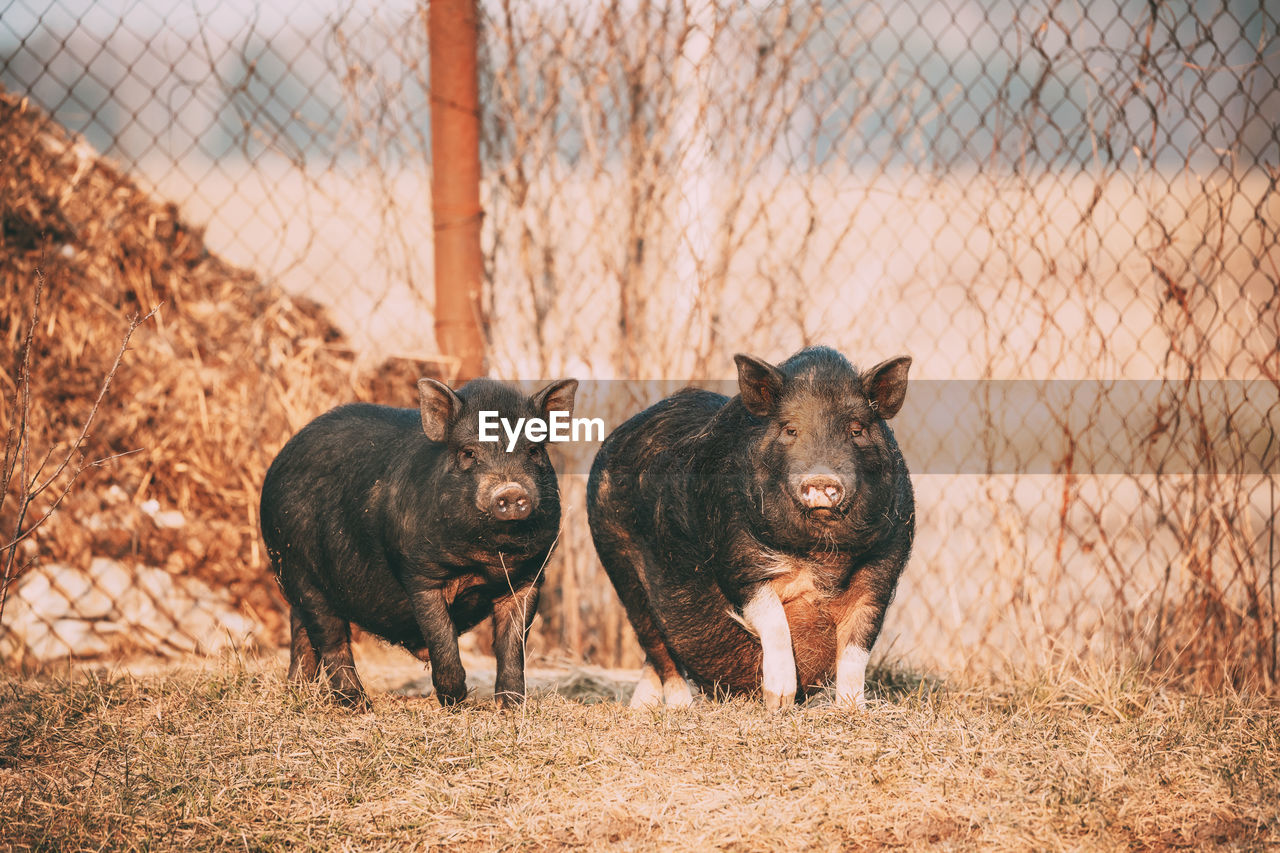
[426,0,485,380]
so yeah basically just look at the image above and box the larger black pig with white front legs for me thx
[588,347,915,708]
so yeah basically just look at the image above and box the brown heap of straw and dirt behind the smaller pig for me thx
[0,91,440,650]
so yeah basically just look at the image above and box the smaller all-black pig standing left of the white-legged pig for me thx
[261,379,577,708]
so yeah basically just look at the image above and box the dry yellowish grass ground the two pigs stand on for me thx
[0,650,1280,849]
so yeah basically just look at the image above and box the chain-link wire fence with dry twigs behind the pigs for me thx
[0,0,1280,684]
